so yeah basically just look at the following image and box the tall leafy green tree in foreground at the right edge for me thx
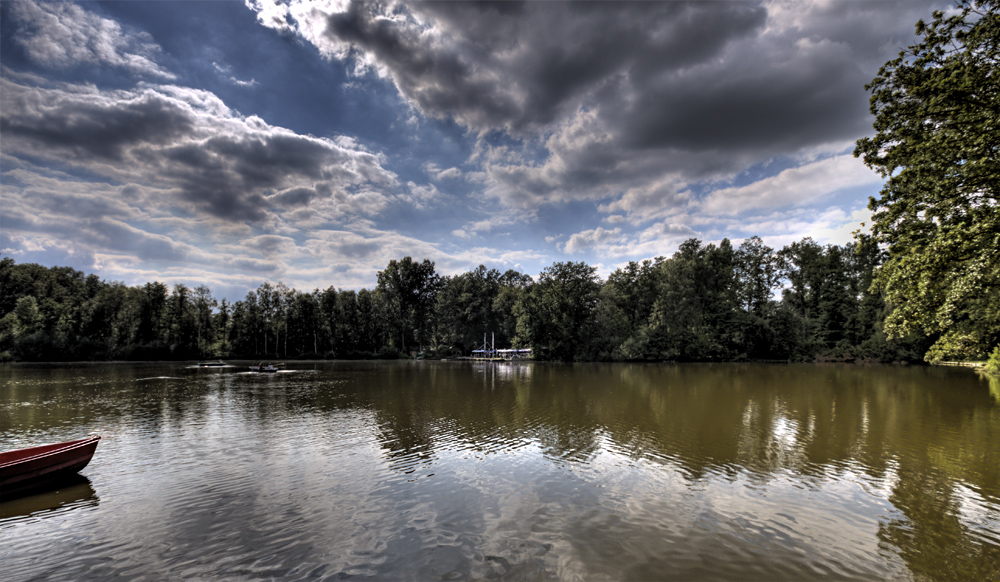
[854,0,1000,361]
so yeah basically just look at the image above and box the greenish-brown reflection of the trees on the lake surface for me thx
[0,362,1000,579]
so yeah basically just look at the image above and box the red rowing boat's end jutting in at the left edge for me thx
[0,436,101,497]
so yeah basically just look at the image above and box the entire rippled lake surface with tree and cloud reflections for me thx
[0,362,1000,581]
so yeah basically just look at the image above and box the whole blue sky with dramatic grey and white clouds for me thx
[0,0,949,300]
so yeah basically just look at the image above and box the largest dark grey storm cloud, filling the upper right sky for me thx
[249,0,942,206]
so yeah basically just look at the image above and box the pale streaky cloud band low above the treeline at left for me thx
[0,157,540,297]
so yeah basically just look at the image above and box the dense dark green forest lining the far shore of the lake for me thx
[0,237,935,361]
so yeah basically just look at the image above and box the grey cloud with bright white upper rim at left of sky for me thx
[0,79,395,221]
